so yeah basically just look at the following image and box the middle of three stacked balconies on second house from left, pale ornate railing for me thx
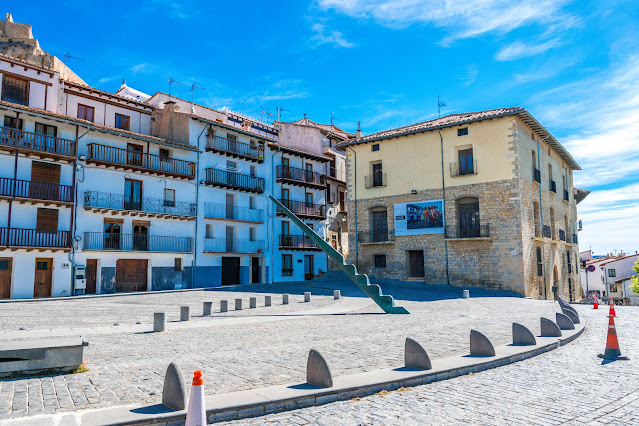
[84,191,195,220]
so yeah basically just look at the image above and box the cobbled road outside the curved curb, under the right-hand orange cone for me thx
[227,306,639,425]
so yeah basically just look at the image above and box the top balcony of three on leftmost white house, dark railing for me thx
[0,127,76,161]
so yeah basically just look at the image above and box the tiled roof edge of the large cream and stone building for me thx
[348,107,581,170]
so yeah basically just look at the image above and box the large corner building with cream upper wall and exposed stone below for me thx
[343,107,583,300]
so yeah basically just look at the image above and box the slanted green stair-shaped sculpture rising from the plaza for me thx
[269,195,410,314]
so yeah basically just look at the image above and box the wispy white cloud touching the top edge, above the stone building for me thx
[318,0,577,44]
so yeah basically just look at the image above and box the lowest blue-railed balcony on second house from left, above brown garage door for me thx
[83,232,193,253]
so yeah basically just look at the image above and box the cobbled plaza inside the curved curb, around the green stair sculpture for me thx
[0,286,560,421]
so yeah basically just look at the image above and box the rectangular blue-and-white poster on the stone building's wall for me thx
[395,199,445,235]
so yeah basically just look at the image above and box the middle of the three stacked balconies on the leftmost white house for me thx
[0,178,73,206]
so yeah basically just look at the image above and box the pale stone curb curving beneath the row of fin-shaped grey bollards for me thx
[13,323,585,425]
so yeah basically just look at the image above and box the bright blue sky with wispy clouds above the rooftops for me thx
[3,0,639,254]
